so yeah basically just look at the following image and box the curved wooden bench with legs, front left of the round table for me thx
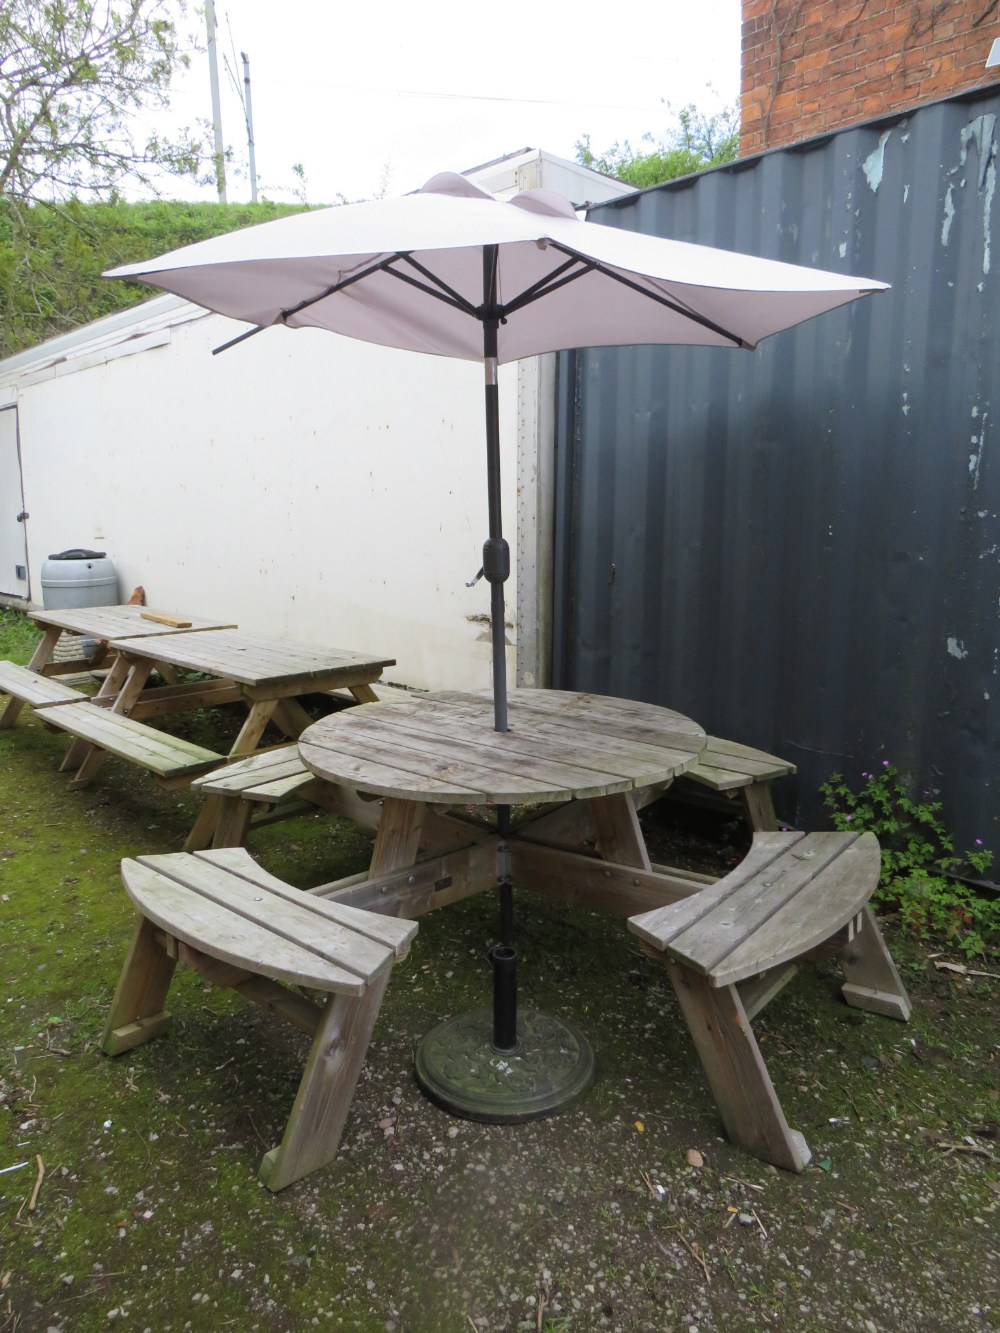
[108,848,417,1190]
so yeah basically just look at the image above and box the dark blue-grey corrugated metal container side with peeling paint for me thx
[555,93,1000,846]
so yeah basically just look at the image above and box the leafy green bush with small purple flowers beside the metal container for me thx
[820,760,1000,956]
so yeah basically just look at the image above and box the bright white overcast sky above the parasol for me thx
[146,0,740,203]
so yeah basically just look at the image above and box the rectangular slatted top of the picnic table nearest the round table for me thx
[111,629,396,686]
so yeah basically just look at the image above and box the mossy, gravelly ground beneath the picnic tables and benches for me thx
[0,618,1000,1333]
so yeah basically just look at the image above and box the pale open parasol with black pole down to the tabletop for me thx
[105,173,887,732]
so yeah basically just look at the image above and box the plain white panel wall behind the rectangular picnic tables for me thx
[19,313,517,688]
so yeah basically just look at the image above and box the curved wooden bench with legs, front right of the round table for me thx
[628,833,909,1170]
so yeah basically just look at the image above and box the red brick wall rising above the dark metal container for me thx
[740,0,1000,156]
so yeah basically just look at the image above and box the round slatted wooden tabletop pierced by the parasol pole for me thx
[299,689,705,805]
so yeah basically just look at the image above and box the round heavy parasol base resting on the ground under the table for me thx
[413,1009,595,1125]
